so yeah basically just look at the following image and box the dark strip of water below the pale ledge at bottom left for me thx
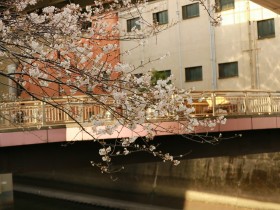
[13,192,116,210]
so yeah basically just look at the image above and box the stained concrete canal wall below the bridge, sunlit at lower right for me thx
[14,153,280,209]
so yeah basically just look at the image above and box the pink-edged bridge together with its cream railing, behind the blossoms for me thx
[0,91,280,147]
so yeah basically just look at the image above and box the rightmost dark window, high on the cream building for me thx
[257,19,275,39]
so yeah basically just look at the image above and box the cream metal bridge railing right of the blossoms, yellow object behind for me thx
[193,91,280,116]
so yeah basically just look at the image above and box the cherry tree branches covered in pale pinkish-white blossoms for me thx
[0,0,225,172]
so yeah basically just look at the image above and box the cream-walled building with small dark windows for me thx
[119,0,280,90]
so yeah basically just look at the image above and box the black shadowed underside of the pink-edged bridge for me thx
[0,129,280,173]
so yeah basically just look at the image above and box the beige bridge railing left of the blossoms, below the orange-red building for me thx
[0,96,110,129]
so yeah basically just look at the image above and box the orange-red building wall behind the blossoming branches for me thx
[0,0,120,100]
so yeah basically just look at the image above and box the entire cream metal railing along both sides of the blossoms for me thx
[0,91,280,129]
